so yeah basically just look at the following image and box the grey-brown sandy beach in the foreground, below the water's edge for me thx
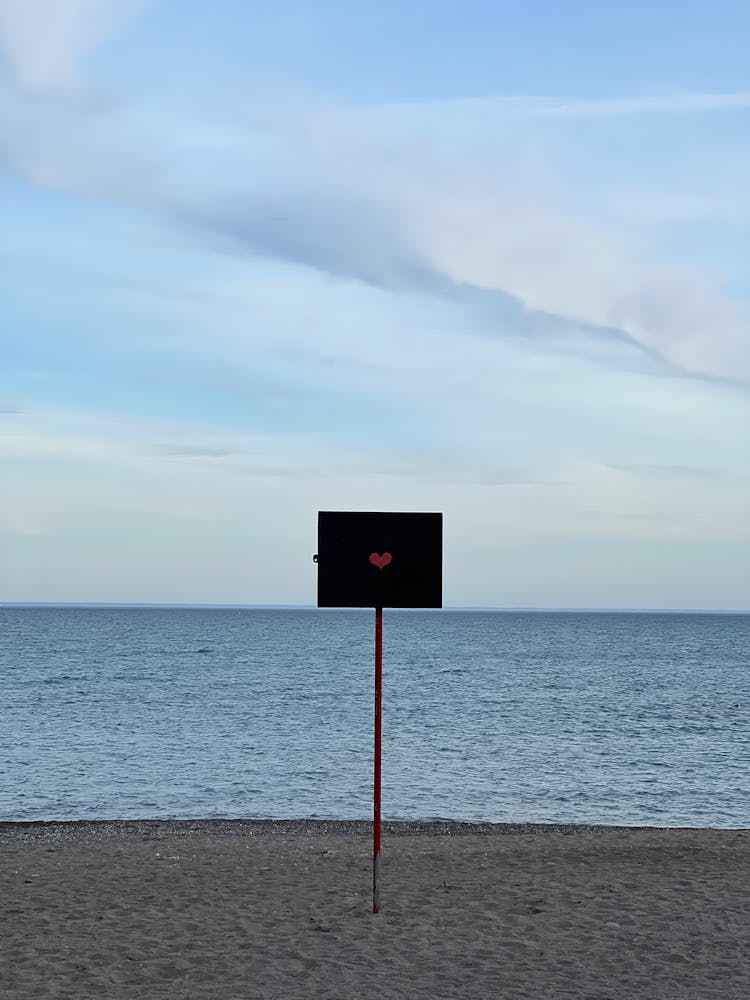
[0,821,750,1000]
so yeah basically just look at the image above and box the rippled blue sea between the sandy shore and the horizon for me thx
[0,606,750,827]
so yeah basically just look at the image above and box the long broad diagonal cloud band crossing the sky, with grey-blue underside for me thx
[5,92,750,378]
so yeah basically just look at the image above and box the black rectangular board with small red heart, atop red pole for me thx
[315,511,443,608]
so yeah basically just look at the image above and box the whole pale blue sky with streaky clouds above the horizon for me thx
[0,0,750,610]
